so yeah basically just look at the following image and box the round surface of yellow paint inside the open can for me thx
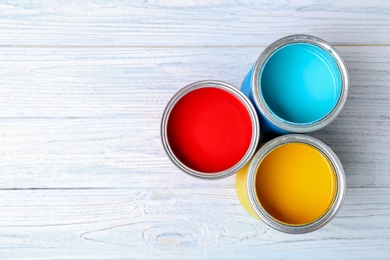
[256,143,337,225]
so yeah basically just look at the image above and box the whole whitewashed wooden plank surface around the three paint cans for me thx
[0,0,390,259]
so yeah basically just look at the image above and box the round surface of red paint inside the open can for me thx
[167,87,252,173]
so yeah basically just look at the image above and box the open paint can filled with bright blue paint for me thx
[241,34,350,134]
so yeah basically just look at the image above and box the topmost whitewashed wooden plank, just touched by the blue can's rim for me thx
[0,0,390,46]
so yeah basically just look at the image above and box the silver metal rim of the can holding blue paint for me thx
[251,34,350,133]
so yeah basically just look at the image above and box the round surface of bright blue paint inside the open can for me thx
[259,43,341,125]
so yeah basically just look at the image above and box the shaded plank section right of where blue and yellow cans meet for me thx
[310,116,390,187]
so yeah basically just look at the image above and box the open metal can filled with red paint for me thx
[161,80,260,179]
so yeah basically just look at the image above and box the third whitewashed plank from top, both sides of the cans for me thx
[0,116,390,188]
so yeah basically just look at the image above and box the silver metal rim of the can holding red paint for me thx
[160,80,260,180]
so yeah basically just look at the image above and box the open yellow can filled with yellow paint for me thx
[236,134,346,234]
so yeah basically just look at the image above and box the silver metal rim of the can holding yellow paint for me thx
[246,134,346,234]
